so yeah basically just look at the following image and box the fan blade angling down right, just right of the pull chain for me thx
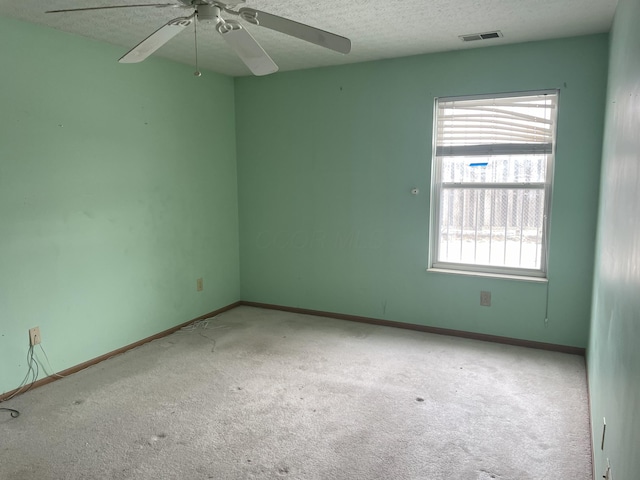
[217,20,278,76]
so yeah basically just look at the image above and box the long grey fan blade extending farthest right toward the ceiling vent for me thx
[238,7,351,53]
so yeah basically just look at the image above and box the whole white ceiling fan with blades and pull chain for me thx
[46,0,351,76]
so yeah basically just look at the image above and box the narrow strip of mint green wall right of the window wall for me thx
[587,0,640,480]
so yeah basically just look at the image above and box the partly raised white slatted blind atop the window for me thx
[436,93,557,157]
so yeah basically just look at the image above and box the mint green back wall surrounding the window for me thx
[235,35,608,347]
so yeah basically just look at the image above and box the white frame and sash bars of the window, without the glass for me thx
[428,90,559,280]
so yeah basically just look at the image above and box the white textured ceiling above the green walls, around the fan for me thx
[0,0,617,76]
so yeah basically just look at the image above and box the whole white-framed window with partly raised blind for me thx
[430,90,558,277]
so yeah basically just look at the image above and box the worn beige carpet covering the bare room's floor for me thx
[0,307,591,480]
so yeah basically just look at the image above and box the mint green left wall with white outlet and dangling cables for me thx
[0,18,239,393]
